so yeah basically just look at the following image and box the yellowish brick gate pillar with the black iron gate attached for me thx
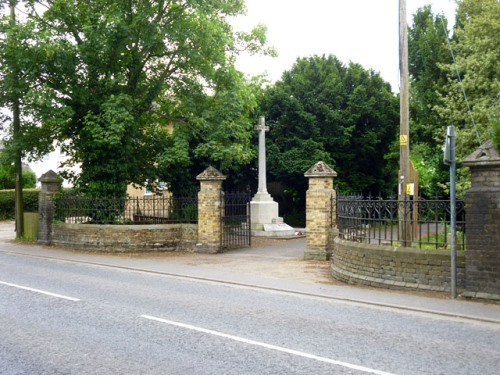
[195,167,226,254]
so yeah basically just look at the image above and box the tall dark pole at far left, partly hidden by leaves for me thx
[8,0,24,238]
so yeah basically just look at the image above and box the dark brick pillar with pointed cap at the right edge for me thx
[462,140,500,299]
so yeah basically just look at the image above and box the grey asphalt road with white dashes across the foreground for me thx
[0,252,500,375]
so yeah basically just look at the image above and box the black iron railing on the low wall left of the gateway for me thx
[54,194,198,224]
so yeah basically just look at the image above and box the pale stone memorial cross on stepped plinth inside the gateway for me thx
[250,117,295,237]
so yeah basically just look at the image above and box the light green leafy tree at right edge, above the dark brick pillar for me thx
[436,0,500,195]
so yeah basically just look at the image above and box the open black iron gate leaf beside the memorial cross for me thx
[221,191,251,250]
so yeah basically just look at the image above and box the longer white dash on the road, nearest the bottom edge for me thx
[141,315,393,375]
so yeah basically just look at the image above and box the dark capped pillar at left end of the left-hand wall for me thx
[38,170,63,245]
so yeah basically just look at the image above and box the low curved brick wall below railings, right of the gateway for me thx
[331,237,465,291]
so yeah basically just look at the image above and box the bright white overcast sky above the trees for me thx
[233,0,456,92]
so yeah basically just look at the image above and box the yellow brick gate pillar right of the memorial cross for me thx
[304,161,337,260]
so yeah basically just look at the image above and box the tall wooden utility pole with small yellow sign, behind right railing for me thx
[398,0,412,247]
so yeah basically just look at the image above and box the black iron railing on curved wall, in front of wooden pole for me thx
[332,196,466,250]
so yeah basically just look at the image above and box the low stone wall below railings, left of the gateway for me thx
[51,223,197,252]
